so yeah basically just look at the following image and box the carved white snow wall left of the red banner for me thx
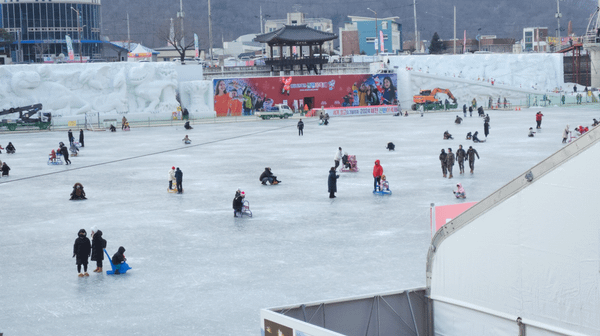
[0,62,214,119]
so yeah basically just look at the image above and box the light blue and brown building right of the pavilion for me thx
[339,16,402,56]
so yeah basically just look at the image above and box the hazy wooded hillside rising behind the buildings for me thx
[102,0,596,48]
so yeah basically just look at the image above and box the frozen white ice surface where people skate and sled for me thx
[0,106,600,335]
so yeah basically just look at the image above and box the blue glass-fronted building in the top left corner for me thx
[0,0,102,63]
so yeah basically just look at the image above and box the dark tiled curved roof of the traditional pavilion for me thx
[254,24,338,44]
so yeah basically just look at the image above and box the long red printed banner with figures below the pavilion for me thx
[213,74,398,117]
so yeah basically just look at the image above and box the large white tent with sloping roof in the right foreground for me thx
[428,128,600,336]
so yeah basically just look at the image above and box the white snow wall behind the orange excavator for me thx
[378,54,565,109]
